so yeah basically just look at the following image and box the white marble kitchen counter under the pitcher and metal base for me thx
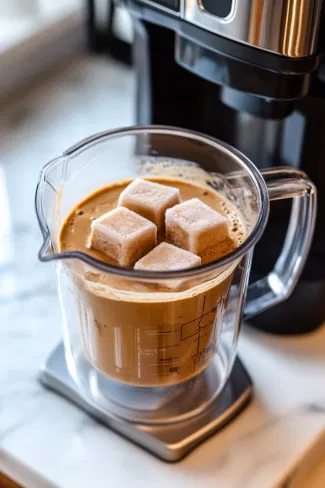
[0,54,325,488]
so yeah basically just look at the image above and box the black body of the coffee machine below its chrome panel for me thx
[129,0,325,334]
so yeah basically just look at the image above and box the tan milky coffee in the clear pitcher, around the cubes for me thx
[59,178,245,386]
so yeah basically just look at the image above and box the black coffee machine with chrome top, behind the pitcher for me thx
[104,0,325,334]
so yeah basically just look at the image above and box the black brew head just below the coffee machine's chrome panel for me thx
[127,0,320,118]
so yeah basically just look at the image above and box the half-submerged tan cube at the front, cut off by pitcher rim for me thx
[134,242,201,271]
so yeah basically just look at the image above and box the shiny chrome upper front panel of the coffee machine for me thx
[132,0,324,56]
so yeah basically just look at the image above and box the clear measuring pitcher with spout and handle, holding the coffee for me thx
[36,126,316,423]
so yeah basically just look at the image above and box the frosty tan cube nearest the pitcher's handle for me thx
[166,198,229,255]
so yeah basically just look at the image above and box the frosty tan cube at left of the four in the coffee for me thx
[90,207,157,266]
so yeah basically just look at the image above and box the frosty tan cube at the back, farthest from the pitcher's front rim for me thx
[118,179,181,229]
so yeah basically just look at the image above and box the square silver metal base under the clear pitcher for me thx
[40,343,252,461]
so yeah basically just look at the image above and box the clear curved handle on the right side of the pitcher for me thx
[244,168,317,319]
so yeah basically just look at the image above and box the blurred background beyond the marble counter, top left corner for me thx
[0,0,133,101]
